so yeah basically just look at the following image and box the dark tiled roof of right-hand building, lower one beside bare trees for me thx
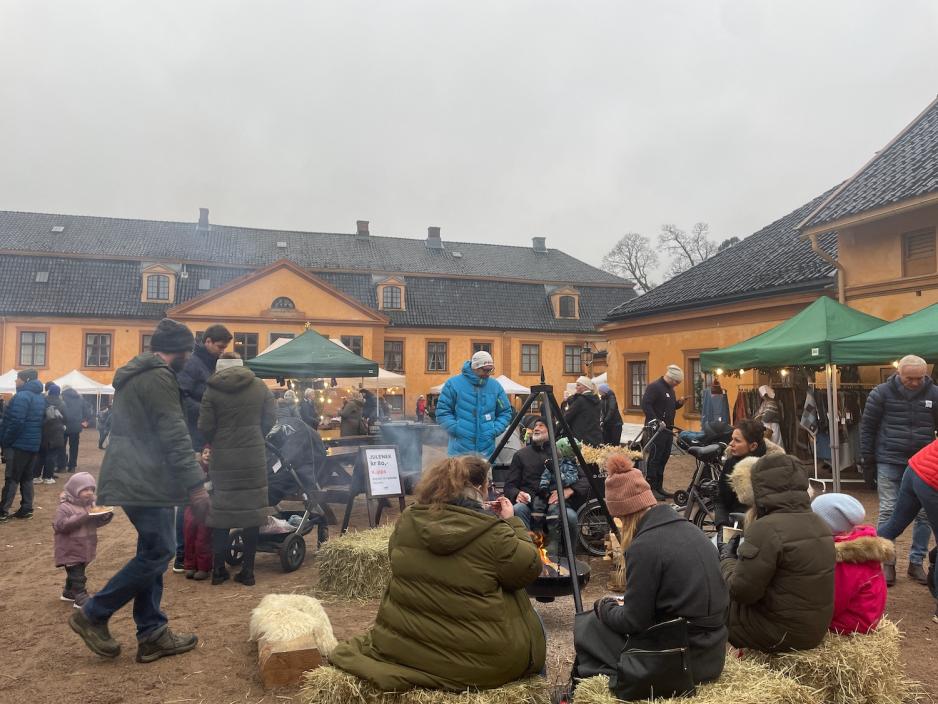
[606,189,837,320]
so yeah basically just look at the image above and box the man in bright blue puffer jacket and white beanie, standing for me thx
[436,352,512,458]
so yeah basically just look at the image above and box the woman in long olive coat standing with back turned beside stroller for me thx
[198,357,276,586]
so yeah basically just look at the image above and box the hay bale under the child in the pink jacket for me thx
[746,619,922,704]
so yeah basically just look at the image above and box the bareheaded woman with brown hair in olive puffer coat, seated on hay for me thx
[330,456,546,691]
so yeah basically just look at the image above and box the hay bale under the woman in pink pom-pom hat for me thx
[573,654,818,704]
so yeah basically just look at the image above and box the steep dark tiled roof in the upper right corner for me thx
[803,95,938,228]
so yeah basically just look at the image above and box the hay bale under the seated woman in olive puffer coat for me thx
[300,667,551,704]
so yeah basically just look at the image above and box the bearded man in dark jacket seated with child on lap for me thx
[503,417,590,556]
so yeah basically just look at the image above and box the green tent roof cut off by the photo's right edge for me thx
[831,303,938,364]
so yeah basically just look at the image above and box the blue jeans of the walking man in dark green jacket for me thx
[84,506,173,642]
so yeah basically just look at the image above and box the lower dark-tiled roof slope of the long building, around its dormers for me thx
[0,255,631,333]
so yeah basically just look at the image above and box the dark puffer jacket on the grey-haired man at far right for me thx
[860,374,938,465]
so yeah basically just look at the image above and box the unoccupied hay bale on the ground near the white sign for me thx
[316,525,394,600]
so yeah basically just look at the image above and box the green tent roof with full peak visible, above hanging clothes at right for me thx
[700,296,885,369]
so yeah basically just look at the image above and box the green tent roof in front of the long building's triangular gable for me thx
[247,330,378,379]
